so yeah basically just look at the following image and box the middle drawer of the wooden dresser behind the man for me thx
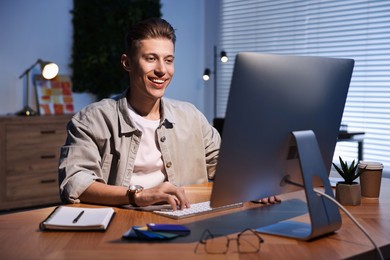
[6,145,60,175]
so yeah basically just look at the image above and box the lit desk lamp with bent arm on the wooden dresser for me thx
[17,59,59,116]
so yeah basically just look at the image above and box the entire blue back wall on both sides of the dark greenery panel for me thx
[0,0,211,121]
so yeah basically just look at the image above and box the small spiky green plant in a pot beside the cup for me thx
[332,156,363,205]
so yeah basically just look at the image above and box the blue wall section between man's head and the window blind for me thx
[161,0,210,120]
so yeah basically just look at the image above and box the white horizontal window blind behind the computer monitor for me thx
[217,0,390,177]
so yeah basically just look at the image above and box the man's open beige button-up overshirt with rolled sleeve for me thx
[59,89,221,203]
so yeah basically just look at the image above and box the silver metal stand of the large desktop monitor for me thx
[257,130,341,240]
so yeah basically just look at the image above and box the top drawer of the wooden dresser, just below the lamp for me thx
[6,124,66,150]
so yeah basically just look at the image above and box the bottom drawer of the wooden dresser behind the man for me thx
[6,173,60,201]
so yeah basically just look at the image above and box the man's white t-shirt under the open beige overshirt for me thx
[129,105,166,189]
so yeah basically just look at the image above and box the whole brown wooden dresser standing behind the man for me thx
[0,115,71,210]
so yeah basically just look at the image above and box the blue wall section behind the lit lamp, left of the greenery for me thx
[0,0,72,114]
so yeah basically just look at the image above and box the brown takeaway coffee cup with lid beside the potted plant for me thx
[358,161,383,198]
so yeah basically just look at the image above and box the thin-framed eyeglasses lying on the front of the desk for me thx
[194,229,264,254]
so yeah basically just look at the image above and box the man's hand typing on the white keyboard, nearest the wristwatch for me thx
[134,182,190,210]
